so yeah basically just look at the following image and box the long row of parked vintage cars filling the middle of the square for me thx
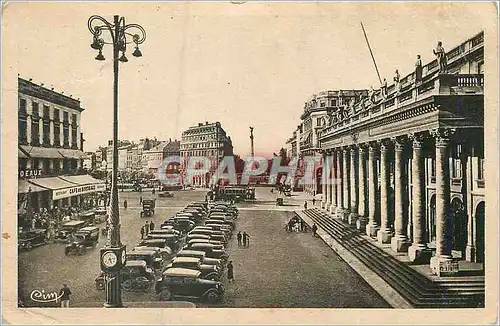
[155,202,238,303]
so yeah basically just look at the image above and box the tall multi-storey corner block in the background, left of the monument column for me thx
[180,121,233,187]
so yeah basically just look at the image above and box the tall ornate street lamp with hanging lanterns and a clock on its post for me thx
[88,15,146,308]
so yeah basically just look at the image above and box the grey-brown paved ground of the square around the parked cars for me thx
[19,188,389,308]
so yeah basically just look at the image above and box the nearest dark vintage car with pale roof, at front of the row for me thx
[155,268,224,303]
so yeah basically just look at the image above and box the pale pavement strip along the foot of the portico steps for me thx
[294,211,413,309]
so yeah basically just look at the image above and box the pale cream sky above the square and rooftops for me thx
[2,2,495,155]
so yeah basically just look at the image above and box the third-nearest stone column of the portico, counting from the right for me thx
[391,137,410,252]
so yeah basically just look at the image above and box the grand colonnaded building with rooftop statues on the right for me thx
[319,32,485,276]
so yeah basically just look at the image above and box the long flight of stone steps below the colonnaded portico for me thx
[303,208,484,308]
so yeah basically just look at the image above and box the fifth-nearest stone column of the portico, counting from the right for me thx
[366,143,380,237]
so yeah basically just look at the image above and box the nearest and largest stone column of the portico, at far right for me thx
[430,129,458,276]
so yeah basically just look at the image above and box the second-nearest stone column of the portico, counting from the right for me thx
[408,134,431,263]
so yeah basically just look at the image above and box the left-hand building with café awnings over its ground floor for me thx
[18,78,104,213]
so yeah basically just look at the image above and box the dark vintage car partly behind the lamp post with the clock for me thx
[95,260,155,291]
